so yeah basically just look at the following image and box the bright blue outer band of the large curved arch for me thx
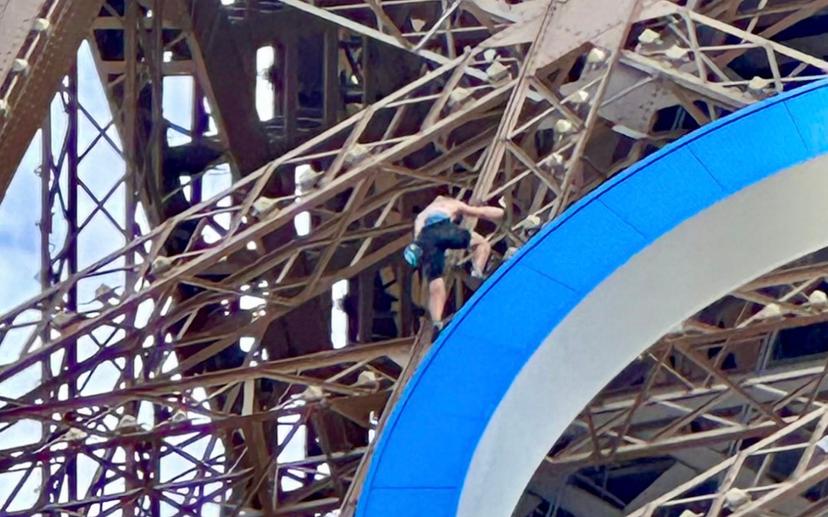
[357,78,828,517]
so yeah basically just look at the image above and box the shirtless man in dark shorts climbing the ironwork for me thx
[403,196,503,332]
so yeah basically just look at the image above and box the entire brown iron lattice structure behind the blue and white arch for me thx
[0,0,828,515]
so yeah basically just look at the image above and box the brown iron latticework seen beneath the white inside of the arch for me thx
[519,252,828,515]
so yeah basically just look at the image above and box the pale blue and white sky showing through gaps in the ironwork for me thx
[0,35,347,517]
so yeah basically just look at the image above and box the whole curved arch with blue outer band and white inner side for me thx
[357,78,828,517]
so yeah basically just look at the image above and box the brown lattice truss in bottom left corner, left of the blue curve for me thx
[0,339,411,515]
